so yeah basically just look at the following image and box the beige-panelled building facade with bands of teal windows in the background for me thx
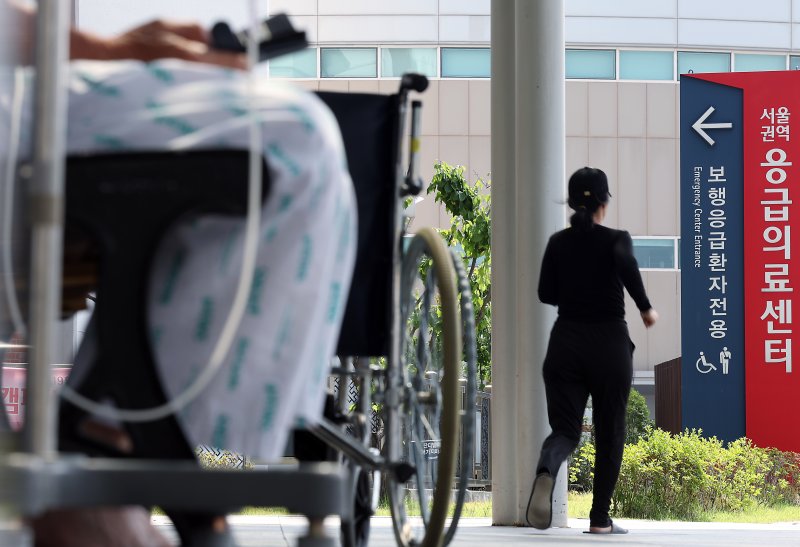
[77,0,800,408]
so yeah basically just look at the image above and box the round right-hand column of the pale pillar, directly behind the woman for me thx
[516,0,567,526]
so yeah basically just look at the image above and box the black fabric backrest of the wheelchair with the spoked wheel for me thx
[318,92,400,357]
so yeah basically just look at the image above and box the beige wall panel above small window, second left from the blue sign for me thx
[612,138,647,235]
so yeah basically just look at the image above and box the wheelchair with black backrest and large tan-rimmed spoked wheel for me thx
[311,78,477,546]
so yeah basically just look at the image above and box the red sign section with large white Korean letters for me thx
[693,71,800,452]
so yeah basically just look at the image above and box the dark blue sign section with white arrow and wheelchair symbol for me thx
[680,75,745,441]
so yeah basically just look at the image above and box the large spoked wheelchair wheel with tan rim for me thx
[387,228,462,547]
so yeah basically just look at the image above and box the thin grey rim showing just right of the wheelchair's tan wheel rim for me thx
[442,249,478,546]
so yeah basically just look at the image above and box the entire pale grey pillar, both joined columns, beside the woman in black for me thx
[492,0,567,526]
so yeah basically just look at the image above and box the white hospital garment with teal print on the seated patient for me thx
[61,60,357,459]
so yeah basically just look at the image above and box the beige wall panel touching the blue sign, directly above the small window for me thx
[647,139,680,236]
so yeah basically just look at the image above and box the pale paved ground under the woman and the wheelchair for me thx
[154,516,800,547]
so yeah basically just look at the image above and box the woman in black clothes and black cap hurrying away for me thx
[526,167,658,534]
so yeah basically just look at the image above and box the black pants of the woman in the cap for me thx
[537,319,634,526]
